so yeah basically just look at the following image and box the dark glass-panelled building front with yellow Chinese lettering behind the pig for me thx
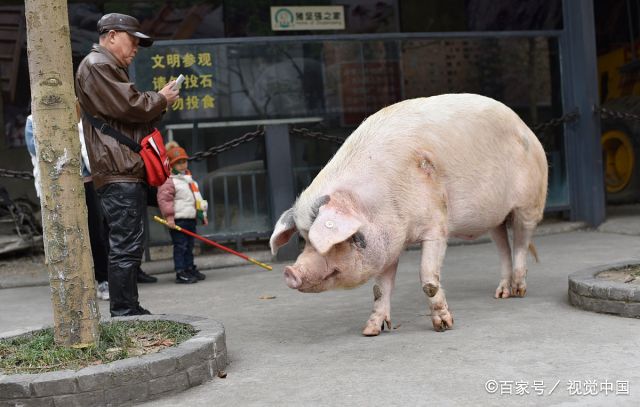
[0,0,605,255]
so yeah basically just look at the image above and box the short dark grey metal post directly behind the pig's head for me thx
[264,124,298,260]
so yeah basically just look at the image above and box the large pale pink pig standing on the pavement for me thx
[269,94,547,336]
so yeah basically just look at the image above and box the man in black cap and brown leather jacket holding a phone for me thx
[76,13,178,316]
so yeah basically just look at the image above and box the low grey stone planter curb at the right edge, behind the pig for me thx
[569,259,640,318]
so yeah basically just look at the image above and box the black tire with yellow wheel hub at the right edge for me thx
[600,124,640,204]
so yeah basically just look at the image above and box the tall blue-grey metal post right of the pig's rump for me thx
[560,0,606,226]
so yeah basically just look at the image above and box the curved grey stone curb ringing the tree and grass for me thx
[0,315,227,407]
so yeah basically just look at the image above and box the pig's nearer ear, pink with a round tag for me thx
[309,205,362,255]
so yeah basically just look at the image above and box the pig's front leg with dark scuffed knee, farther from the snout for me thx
[420,238,453,332]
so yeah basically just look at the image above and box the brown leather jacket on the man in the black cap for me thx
[76,44,167,189]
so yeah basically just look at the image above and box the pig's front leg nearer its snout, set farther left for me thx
[362,261,398,336]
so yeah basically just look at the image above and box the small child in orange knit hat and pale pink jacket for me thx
[158,141,207,284]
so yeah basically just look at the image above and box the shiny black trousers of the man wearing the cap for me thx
[97,182,147,317]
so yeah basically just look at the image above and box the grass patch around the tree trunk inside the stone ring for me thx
[0,321,196,374]
